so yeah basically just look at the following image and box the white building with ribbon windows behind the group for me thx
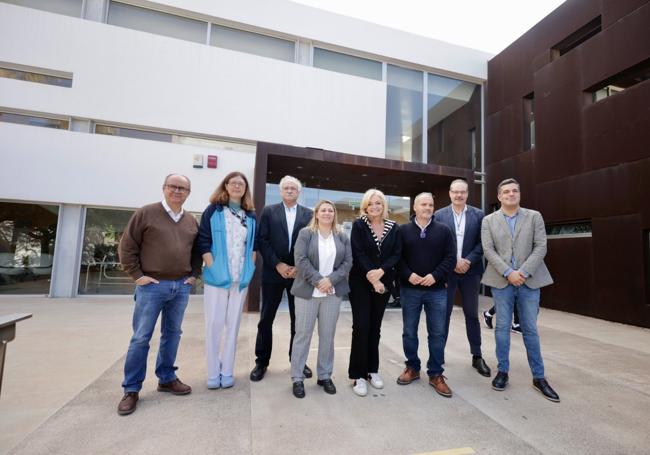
[0,0,491,297]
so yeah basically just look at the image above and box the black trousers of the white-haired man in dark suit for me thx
[255,280,296,366]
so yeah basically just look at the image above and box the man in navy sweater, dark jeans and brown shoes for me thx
[397,193,456,397]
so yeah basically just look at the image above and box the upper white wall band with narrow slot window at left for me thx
[0,3,386,157]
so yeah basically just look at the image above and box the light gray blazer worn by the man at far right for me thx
[481,208,553,289]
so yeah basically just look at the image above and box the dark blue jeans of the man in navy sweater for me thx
[400,286,447,376]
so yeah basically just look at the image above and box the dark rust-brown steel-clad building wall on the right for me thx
[485,0,650,327]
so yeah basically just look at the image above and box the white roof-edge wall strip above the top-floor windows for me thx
[143,0,486,82]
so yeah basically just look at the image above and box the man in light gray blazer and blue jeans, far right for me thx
[481,179,560,402]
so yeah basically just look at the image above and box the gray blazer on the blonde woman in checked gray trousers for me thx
[291,227,352,299]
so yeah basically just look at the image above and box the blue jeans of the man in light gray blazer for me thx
[492,284,544,379]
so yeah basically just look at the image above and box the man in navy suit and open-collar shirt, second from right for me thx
[434,179,491,377]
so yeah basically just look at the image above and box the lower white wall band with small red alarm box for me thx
[0,123,255,212]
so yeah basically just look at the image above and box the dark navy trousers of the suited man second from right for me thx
[445,273,481,357]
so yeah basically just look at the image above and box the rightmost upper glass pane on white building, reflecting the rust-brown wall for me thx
[427,74,481,170]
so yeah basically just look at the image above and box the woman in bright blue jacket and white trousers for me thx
[197,172,255,389]
